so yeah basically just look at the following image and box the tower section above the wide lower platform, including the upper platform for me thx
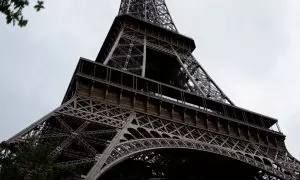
[96,0,234,105]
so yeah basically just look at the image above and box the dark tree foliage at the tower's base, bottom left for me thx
[0,143,76,180]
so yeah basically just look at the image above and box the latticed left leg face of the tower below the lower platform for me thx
[7,96,130,172]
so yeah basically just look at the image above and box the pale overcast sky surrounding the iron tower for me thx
[0,0,300,159]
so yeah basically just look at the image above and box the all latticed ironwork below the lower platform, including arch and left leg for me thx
[7,96,300,179]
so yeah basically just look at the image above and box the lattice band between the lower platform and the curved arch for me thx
[128,114,300,173]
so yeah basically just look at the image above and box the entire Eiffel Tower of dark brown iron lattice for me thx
[7,0,300,180]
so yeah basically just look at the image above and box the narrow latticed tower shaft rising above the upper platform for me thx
[119,0,177,32]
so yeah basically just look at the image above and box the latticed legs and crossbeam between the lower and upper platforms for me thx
[103,27,233,105]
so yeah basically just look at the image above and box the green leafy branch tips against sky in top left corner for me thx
[0,0,45,27]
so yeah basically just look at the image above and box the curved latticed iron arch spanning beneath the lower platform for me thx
[100,138,288,179]
